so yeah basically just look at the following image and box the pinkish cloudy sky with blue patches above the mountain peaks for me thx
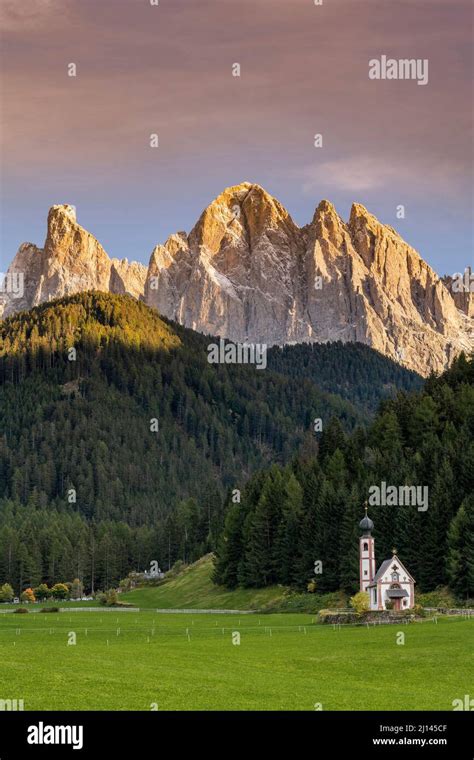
[0,0,473,273]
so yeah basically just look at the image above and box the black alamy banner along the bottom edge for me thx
[0,708,474,760]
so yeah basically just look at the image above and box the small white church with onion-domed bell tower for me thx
[359,506,415,610]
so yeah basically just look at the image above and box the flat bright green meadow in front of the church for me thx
[0,610,474,710]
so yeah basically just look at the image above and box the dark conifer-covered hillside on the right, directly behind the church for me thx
[214,355,474,599]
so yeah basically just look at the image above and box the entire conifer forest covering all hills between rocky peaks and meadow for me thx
[0,293,474,596]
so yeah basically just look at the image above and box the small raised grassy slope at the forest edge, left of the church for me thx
[120,555,285,610]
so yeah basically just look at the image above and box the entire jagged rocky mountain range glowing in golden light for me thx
[0,183,474,376]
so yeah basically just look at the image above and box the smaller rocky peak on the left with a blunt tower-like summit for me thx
[0,205,147,317]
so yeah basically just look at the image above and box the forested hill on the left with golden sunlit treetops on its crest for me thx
[0,292,419,589]
